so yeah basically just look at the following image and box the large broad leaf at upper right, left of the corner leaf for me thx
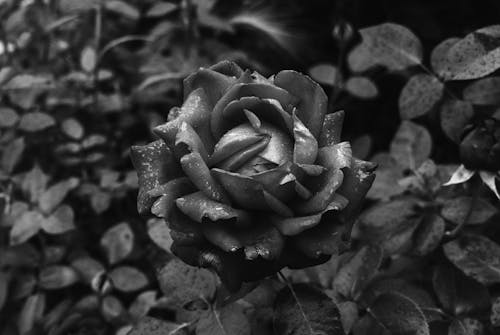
[347,23,422,72]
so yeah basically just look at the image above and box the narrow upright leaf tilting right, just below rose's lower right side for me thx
[333,245,383,300]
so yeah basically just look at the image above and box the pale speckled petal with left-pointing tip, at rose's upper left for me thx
[153,88,214,151]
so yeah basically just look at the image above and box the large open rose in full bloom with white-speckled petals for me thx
[131,61,375,290]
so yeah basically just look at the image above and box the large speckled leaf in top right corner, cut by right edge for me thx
[443,25,500,80]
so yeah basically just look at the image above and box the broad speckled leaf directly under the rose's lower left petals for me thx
[157,259,217,308]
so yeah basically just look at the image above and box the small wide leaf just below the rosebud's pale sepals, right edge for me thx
[441,196,498,224]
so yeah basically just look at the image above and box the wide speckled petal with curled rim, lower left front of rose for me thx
[175,192,250,226]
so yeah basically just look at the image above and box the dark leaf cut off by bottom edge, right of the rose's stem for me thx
[369,293,430,335]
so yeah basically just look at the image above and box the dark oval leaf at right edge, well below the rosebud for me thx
[443,235,500,285]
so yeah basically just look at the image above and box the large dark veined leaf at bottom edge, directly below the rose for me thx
[274,284,344,335]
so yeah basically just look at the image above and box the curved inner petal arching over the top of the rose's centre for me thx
[210,83,297,138]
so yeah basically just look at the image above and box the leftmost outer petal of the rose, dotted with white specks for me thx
[130,140,182,214]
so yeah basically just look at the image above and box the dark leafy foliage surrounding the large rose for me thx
[0,0,500,335]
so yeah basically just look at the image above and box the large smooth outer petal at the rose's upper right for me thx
[274,70,328,138]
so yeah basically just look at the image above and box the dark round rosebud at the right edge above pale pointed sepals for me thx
[460,119,500,171]
